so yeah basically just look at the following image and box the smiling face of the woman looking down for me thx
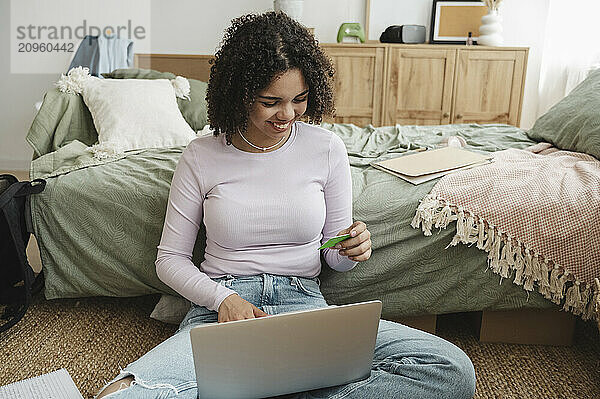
[240,69,308,150]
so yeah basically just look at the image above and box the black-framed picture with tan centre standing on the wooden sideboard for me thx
[429,0,488,44]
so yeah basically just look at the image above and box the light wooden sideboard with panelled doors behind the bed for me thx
[322,44,528,126]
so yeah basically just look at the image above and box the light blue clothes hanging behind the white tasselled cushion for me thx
[68,35,133,78]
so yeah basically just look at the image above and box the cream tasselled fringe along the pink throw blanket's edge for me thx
[411,194,600,321]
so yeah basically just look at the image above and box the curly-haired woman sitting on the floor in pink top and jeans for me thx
[99,12,475,399]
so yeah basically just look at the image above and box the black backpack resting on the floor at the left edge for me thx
[0,175,46,332]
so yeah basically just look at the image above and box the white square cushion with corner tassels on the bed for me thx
[82,78,196,151]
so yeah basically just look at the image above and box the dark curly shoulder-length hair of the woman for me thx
[206,11,335,144]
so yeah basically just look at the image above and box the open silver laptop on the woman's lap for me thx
[190,301,381,399]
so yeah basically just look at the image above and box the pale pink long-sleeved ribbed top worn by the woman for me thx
[156,122,356,311]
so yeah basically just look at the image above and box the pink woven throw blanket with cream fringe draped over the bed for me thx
[411,143,600,320]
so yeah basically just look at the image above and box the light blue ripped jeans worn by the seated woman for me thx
[96,274,475,399]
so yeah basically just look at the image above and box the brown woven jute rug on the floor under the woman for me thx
[0,295,600,399]
